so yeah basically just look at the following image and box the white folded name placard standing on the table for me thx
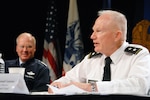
[0,73,29,94]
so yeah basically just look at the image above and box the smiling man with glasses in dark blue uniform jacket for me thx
[5,32,50,92]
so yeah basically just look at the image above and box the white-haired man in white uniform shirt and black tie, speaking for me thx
[48,10,150,95]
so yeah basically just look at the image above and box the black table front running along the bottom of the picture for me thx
[0,93,150,100]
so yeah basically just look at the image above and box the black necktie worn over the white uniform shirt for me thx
[103,57,112,81]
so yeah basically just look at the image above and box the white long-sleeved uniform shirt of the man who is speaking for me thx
[56,42,150,95]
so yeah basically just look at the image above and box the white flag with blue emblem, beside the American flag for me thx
[62,0,84,75]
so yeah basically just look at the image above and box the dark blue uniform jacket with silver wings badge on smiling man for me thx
[5,58,50,92]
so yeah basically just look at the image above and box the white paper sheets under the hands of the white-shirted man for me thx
[48,85,87,95]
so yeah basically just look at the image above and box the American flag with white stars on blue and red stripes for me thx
[42,0,60,82]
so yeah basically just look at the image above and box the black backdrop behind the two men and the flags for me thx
[0,0,150,59]
